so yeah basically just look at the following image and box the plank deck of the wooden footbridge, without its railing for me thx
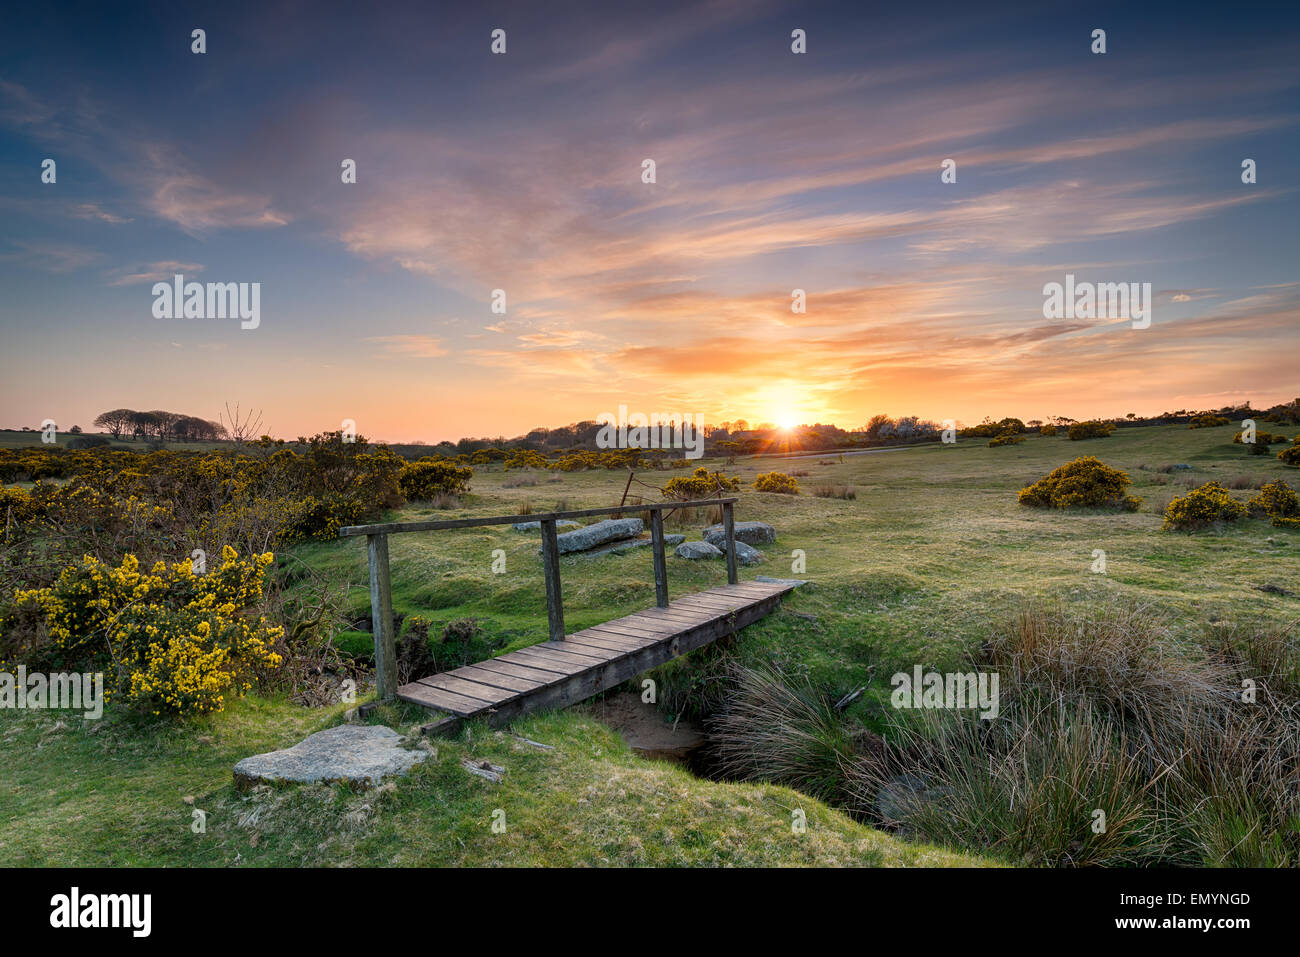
[397,581,794,726]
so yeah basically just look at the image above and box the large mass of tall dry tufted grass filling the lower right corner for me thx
[849,605,1300,866]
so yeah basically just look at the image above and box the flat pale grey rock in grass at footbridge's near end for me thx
[235,724,429,787]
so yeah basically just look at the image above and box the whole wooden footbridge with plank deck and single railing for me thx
[339,498,793,732]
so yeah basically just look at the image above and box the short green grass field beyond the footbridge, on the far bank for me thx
[306,425,1300,690]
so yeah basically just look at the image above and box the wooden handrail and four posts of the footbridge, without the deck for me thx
[338,498,738,698]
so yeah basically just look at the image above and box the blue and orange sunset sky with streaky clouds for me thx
[0,0,1300,442]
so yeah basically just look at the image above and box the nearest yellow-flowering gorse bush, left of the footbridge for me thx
[0,547,283,715]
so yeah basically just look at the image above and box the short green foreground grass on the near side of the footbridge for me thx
[0,698,984,867]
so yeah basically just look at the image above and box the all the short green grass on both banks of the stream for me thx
[0,426,1300,865]
